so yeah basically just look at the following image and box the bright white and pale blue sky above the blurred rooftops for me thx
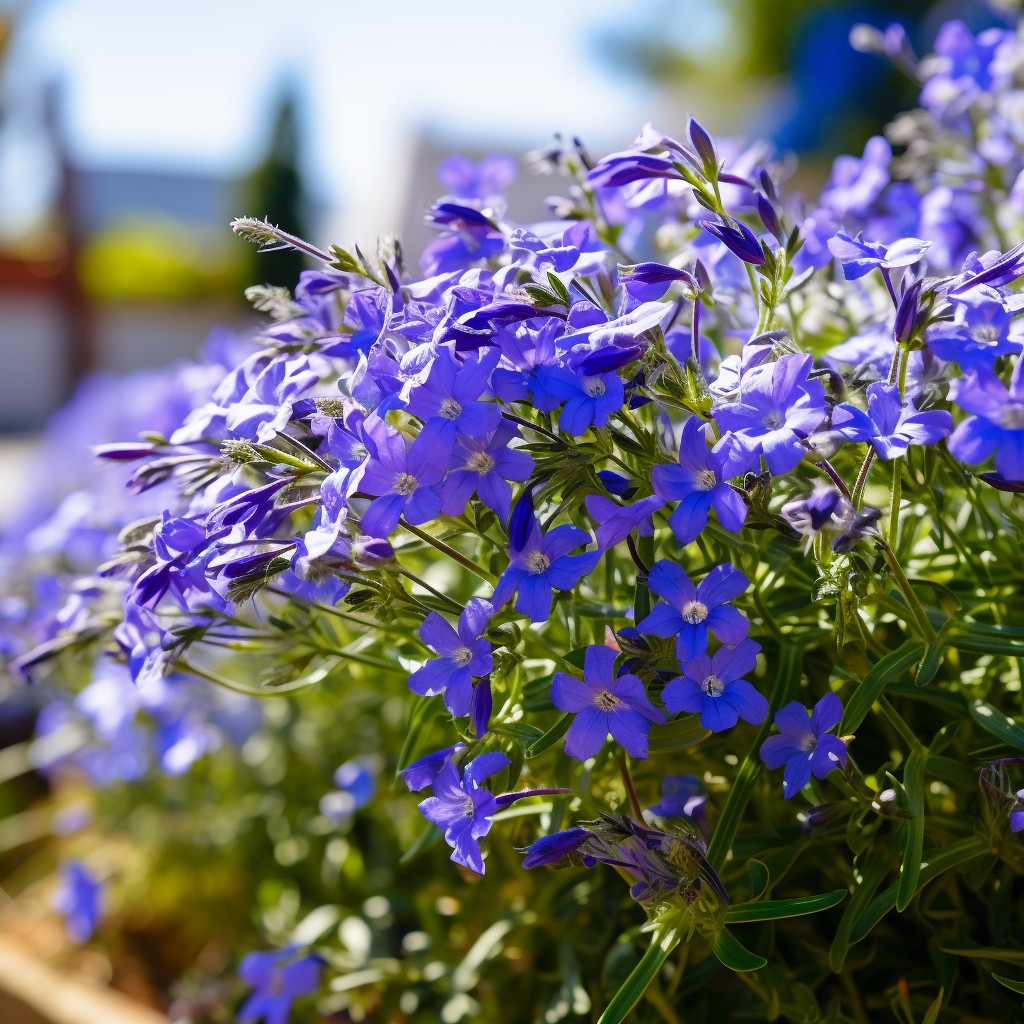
[0,0,715,237]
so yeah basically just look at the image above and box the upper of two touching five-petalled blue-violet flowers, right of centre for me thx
[637,558,751,665]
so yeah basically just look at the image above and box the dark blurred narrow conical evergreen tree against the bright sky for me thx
[239,82,308,288]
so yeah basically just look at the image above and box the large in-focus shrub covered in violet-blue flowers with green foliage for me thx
[6,16,1024,1024]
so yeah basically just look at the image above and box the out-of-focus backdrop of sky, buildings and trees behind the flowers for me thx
[0,0,995,436]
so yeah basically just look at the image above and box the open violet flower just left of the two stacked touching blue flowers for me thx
[551,645,665,761]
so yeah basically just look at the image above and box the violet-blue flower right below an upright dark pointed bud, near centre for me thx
[494,522,600,623]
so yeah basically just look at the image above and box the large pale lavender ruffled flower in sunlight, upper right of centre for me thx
[714,354,825,474]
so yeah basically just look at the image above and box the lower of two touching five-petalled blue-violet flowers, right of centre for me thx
[663,640,768,732]
